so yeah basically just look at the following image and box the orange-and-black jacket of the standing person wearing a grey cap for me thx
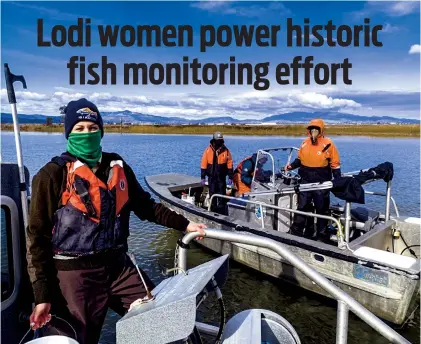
[200,141,233,180]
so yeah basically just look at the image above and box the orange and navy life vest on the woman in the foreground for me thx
[52,155,129,256]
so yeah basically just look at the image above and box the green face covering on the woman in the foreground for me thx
[67,130,102,168]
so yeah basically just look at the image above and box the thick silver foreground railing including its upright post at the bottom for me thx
[177,229,410,344]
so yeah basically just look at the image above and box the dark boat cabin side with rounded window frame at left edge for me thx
[1,163,33,343]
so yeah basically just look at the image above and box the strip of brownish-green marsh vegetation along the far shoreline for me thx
[1,124,420,137]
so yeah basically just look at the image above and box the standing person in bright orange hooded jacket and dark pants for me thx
[285,119,341,237]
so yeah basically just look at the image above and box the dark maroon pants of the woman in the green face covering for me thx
[53,253,154,344]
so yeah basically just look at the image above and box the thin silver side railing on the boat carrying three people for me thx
[208,194,351,249]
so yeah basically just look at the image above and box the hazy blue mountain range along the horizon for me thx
[1,110,420,124]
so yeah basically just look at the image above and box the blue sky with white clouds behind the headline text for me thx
[1,1,420,119]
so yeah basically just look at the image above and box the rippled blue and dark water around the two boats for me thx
[1,132,420,344]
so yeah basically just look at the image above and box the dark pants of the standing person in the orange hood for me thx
[291,190,330,237]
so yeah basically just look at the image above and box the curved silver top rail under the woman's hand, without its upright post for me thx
[178,229,410,344]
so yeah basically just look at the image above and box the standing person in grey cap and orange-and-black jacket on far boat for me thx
[200,131,233,213]
